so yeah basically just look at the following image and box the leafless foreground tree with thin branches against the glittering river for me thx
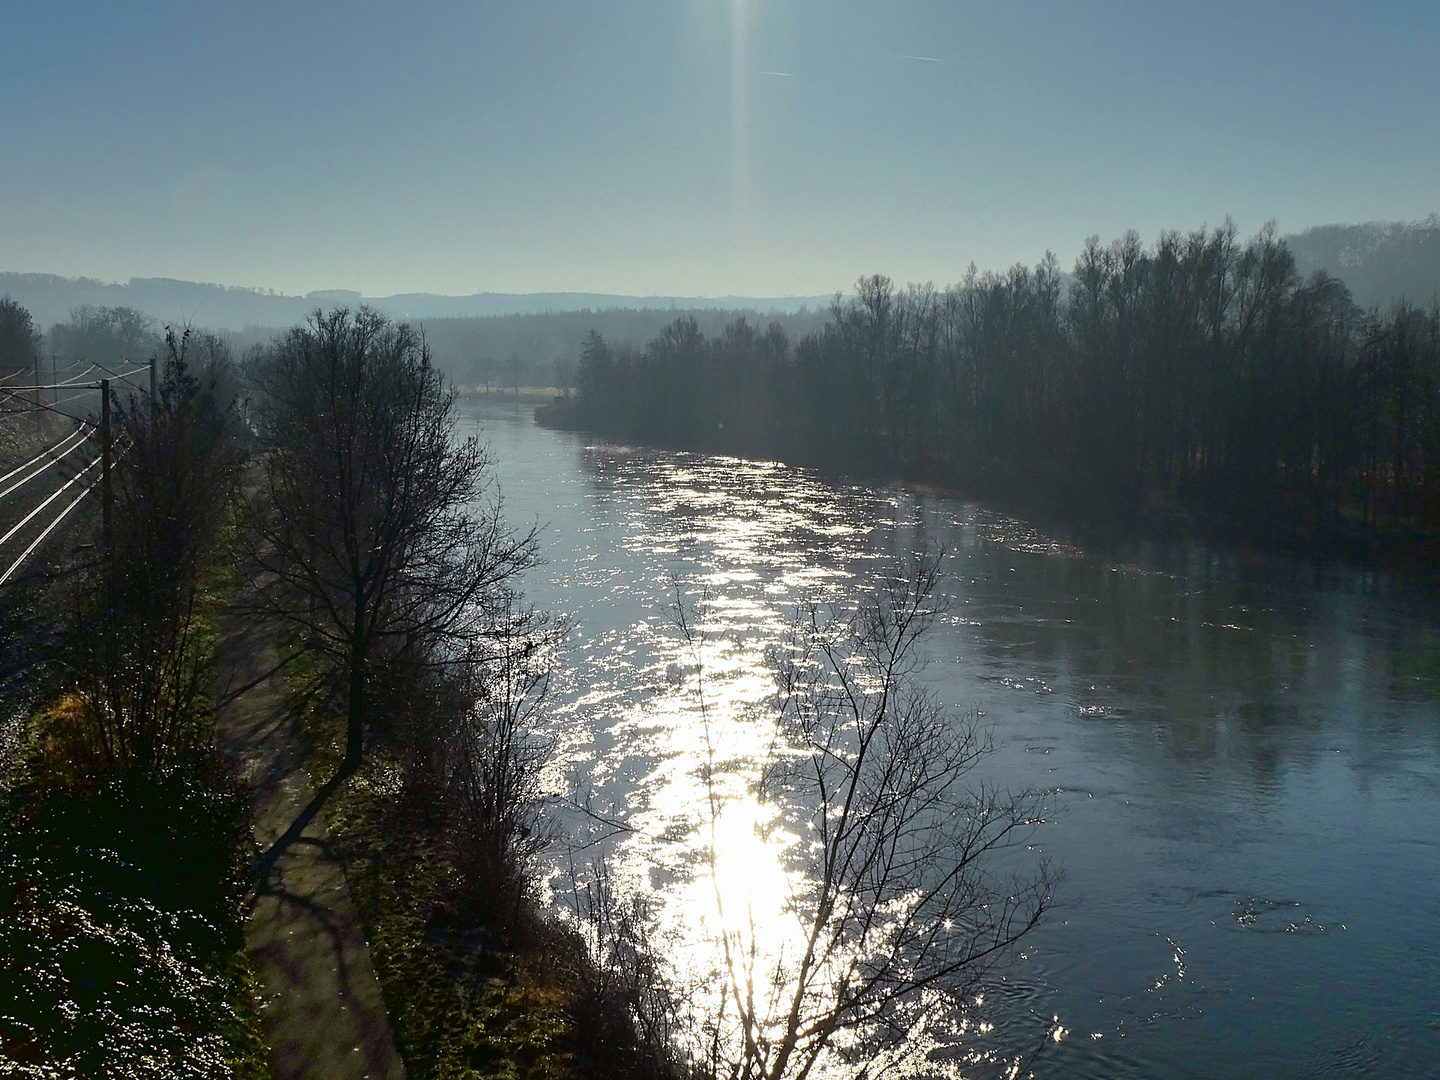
[683,556,1054,1080]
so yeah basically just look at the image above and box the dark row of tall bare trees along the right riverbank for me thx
[541,223,1440,550]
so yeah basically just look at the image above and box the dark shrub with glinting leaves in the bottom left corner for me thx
[0,760,246,1077]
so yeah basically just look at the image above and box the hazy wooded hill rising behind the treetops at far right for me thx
[1284,215,1440,308]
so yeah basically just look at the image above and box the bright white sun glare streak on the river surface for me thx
[527,455,1036,1080]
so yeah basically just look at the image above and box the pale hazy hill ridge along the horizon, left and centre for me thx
[0,274,831,331]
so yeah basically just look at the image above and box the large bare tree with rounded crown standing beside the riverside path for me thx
[251,307,536,779]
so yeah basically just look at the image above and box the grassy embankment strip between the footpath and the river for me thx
[291,642,675,1080]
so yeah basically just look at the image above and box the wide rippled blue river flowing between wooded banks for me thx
[462,400,1440,1077]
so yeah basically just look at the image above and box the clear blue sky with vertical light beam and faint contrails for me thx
[0,0,1440,297]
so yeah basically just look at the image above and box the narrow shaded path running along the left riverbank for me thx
[217,618,405,1080]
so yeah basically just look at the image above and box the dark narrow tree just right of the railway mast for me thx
[68,331,242,775]
